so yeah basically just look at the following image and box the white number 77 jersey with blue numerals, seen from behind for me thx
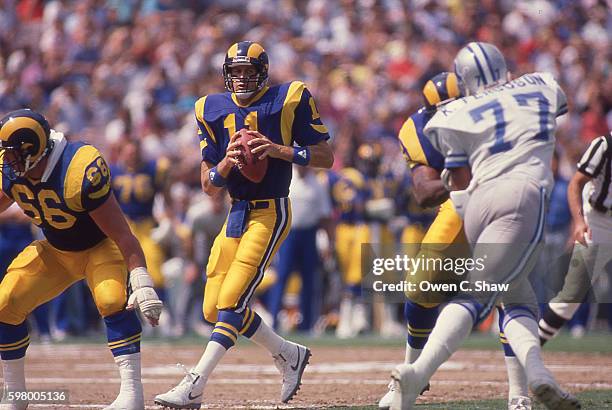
[424,73,567,194]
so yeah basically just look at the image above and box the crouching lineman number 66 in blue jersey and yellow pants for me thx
[0,109,162,410]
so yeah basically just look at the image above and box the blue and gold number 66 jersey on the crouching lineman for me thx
[0,142,111,251]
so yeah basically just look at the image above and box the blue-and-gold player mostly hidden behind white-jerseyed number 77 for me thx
[378,72,531,410]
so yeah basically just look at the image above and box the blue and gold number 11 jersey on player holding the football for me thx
[195,81,329,200]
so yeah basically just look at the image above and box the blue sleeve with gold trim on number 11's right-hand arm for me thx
[292,88,330,147]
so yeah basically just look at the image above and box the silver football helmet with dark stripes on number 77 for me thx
[455,42,508,95]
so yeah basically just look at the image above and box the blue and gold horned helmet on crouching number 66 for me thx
[0,109,51,179]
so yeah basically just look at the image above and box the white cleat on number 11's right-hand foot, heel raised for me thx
[272,342,311,403]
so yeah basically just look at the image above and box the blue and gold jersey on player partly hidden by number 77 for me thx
[398,107,444,172]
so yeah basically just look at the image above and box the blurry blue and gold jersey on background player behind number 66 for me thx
[111,158,170,221]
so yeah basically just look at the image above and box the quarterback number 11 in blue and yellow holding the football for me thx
[155,41,333,408]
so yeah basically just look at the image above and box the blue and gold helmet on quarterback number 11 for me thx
[223,41,268,98]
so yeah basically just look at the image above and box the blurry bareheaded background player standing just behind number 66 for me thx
[110,140,172,302]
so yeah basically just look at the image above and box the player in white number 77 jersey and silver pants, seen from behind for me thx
[391,43,580,410]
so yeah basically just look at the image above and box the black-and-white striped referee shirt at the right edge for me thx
[578,133,612,212]
